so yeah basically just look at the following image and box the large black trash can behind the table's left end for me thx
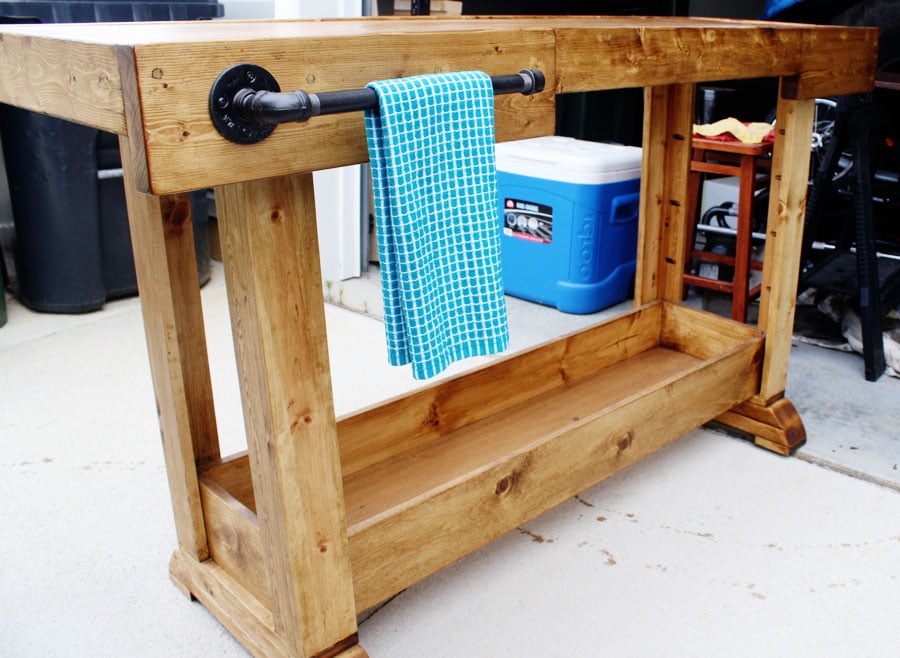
[0,0,224,313]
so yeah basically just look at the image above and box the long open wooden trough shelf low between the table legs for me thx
[193,303,763,611]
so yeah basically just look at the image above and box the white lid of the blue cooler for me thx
[496,136,641,185]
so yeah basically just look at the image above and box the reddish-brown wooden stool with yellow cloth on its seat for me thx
[684,137,772,322]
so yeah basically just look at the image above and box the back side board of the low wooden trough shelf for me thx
[337,305,661,476]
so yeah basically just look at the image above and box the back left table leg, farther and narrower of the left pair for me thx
[119,139,219,560]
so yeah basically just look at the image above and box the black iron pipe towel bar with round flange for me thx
[209,64,544,144]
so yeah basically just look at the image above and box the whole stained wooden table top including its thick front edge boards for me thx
[0,16,877,193]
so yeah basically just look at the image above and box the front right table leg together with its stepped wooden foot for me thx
[719,82,814,455]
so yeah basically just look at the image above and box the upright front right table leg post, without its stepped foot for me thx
[756,84,815,406]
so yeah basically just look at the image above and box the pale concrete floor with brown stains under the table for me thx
[0,264,900,658]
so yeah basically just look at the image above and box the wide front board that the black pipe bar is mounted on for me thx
[129,30,556,193]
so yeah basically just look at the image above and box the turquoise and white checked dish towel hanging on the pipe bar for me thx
[365,71,509,379]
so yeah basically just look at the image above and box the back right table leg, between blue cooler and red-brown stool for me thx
[634,83,695,306]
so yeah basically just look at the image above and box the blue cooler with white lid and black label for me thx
[497,137,641,313]
